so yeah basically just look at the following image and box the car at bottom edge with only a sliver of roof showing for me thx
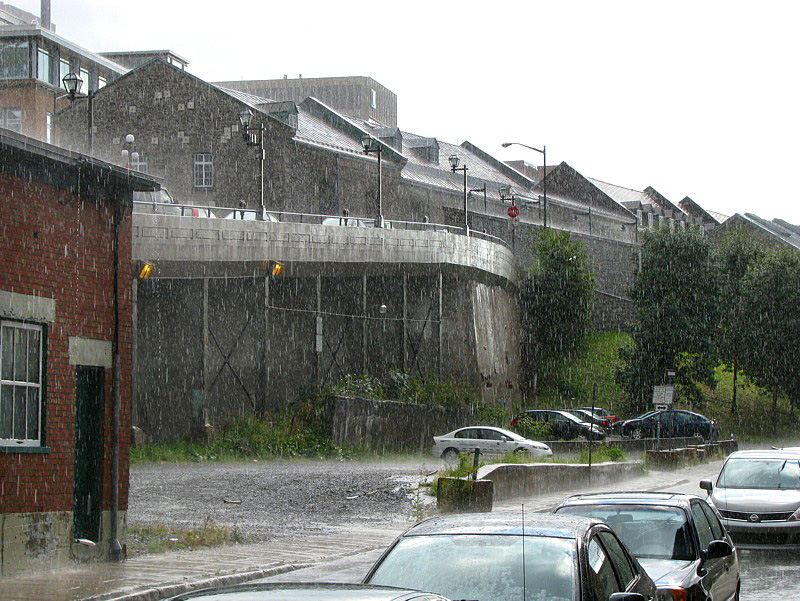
[167,582,448,601]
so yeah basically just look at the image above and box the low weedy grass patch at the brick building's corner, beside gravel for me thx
[127,517,242,555]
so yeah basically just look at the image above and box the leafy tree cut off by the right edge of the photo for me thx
[739,248,800,435]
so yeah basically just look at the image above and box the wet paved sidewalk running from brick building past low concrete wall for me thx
[0,461,721,601]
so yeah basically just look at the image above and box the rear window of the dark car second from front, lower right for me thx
[557,503,695,561]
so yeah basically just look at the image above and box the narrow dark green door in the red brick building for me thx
[72,365,103,542]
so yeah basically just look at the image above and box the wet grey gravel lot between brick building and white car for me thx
[128,456,441,542]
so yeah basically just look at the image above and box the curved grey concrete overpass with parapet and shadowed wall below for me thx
[133,213,523,440]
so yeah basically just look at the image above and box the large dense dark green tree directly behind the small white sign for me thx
[617,227,719,412]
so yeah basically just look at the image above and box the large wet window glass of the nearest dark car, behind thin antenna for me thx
[370,535,576,601]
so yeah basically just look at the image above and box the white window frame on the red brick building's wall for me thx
[0,320,45,448]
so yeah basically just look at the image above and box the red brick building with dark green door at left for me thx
[0,130,158,577]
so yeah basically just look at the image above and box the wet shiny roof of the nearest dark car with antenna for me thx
[403,510,603,539]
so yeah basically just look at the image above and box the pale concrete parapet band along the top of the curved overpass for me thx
[133,213,521,286]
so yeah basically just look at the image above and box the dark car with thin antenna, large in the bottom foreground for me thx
[364,511,656,601]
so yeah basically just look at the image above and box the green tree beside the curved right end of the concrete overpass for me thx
[523,229,594,394]
